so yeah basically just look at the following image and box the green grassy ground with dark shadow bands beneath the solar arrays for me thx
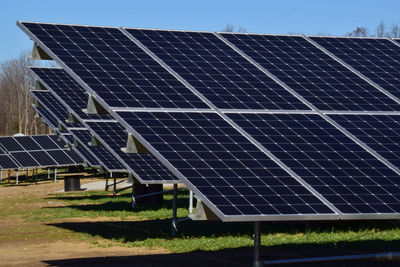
[0,177,400,266]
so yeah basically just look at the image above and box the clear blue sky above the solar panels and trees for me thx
[0,0,400,62]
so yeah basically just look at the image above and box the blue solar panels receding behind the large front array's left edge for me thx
[31,68,177,183]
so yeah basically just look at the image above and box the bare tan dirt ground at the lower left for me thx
[0,180,168,266]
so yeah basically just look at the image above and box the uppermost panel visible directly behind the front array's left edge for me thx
[31,67,111,119]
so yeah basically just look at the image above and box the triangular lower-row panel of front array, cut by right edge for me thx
[329,114,400,168]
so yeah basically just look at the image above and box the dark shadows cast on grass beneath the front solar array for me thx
[45,220,400,267]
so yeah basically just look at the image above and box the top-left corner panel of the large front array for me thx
[22,22,208,108]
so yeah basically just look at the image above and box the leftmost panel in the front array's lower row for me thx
[118,112,333,217]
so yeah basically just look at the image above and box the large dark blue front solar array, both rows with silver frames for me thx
[19,22,400,221]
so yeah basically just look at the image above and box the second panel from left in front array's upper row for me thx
[127,29,309,109]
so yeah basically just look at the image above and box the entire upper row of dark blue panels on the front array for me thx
[18,23,400,114]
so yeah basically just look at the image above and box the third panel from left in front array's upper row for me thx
[221,33,400,111]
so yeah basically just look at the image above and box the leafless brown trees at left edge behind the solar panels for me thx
[0,53,49,135]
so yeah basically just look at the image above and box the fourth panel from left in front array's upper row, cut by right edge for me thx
[310,37,400,100]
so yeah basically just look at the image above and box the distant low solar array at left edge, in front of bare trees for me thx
[0,135,83,169]
